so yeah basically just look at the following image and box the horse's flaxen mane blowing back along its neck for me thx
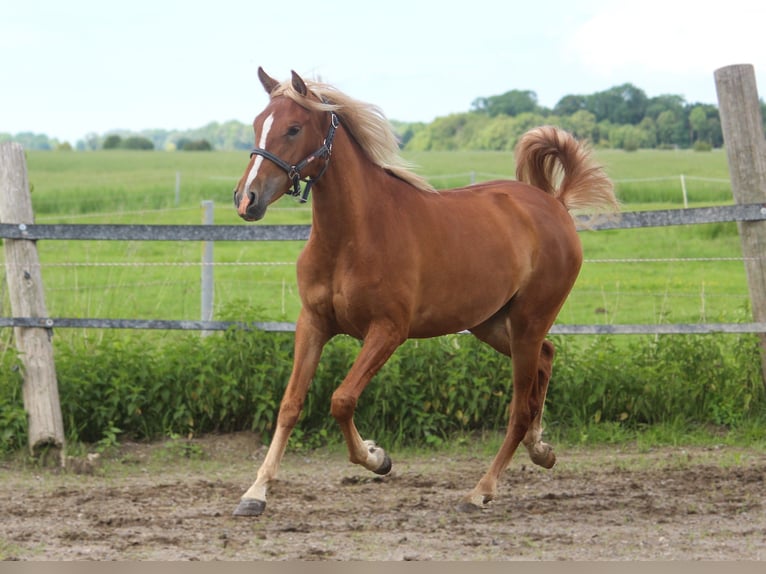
[271,80,434,191]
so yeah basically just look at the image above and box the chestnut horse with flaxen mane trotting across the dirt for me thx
[234,68,616,516]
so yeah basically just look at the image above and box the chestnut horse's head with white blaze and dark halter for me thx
[234,68,339,221]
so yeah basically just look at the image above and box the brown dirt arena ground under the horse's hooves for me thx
[0,433,766,560]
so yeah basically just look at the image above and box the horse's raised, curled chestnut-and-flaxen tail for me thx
[515,126,619,216]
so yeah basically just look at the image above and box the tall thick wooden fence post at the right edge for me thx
[715,64,766,392]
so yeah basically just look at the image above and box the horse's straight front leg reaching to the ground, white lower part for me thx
[234,314,329,516]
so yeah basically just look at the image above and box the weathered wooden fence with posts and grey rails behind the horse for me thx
[0,65,766,460]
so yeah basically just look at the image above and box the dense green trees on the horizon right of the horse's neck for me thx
[398,84,766,151]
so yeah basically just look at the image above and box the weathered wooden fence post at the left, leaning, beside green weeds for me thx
[0,142,65,463]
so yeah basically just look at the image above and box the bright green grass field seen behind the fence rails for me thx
[0,150,750,342]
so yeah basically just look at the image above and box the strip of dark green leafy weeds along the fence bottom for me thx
[0,329,766,456]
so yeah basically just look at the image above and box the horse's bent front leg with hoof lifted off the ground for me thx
[330,326,405,474]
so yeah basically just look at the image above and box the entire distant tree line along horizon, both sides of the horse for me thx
[6,83,766,151]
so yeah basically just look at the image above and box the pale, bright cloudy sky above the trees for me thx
[0,0,766,144]
